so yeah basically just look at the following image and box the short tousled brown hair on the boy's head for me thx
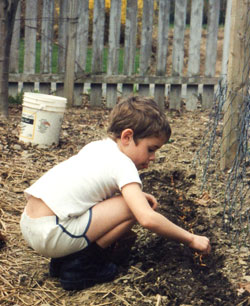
[107,96,171,142]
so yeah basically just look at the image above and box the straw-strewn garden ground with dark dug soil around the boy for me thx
[0,105,250,306]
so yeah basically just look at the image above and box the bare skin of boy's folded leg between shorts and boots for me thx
[86,196,136,248]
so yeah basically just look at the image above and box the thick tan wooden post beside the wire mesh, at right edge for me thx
[221,0,250,170]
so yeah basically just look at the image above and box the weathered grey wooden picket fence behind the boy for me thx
[9,0,231,110]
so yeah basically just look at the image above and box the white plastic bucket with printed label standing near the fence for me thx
[19,92,67,147]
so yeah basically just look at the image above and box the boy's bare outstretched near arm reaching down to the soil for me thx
[122,183,211,253]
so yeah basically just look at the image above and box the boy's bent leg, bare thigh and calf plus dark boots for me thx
[53,196,135,290]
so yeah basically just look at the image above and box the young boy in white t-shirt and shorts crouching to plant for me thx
[20,97,211,290]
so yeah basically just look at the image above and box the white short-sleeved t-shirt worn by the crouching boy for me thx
[25,138,141,220]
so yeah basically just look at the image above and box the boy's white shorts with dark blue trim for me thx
[20,209,92,258]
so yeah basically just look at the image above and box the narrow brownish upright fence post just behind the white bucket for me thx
[64,0,78,106]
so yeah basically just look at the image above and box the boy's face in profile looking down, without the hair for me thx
[124,137,166,170]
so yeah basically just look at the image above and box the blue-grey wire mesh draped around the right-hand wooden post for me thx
[195,83,250,245]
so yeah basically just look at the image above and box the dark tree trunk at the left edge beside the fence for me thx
[0,0,19,118]
